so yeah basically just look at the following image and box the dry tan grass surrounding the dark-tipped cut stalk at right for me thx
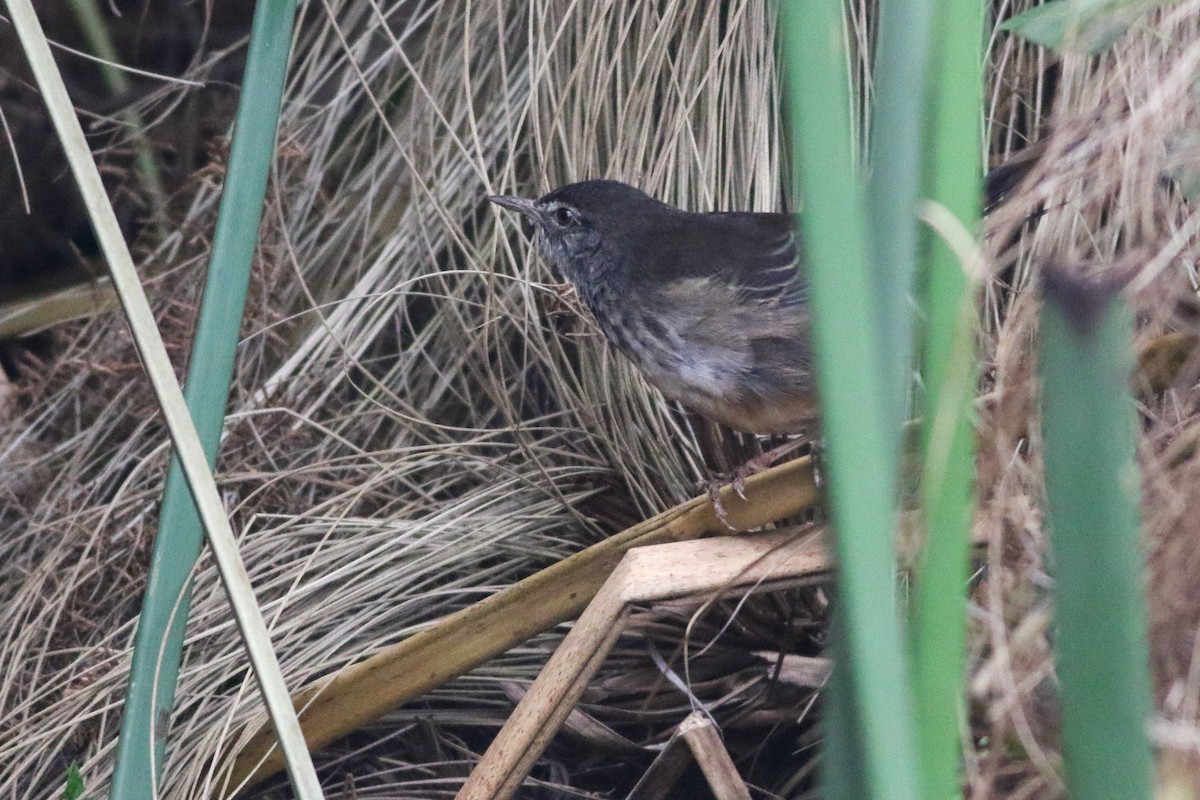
[967,0,1200,799]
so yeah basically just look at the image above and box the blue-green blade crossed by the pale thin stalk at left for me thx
[113,0,302,799]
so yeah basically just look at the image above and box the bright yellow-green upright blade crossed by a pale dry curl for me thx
[911,0,983,798]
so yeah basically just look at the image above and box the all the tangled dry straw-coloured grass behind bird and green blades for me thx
[0,0,1200,799]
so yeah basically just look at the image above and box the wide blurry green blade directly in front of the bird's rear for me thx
[780,0,920,800]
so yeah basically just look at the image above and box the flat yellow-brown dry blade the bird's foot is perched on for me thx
[220,458,817,786]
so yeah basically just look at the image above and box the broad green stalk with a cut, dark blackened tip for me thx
[1040,269,1153,800]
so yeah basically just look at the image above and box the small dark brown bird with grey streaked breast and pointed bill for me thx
[487,180,816,433]
